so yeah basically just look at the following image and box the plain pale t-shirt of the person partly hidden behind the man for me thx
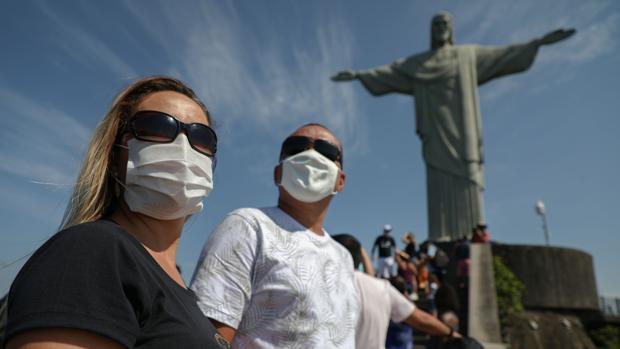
[355,271,415,349]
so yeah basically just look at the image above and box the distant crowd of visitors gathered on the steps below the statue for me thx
[371,223,489,349]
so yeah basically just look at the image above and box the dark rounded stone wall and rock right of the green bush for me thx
[492,244,601,349]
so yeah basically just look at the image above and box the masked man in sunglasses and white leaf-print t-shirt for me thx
[190,124,359,349]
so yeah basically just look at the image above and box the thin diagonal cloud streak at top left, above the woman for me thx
[38,1,138,79]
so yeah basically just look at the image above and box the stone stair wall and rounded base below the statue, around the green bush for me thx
[437,243,602,349]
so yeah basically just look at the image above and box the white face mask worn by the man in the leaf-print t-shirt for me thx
[280,149,339,203]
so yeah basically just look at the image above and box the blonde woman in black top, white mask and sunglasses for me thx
[6,77,228,349]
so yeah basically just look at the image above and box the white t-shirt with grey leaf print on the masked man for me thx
[190,207,360,349]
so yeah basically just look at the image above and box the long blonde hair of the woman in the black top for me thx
[60,76,213,229]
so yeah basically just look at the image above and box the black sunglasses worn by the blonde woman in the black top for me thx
[123,110,217,157]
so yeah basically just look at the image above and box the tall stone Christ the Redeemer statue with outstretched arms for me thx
[332,12,575,241]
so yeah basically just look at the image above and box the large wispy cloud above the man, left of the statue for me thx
[126,1,363,148]
